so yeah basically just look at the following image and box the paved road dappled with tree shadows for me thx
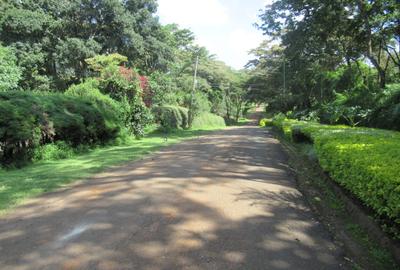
[0,126,342,270]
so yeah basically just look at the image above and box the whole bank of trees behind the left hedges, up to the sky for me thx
[0,0,245,122]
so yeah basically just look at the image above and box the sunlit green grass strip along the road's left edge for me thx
[0,127,220,214]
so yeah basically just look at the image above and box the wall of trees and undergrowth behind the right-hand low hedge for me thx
[248,0,400,129]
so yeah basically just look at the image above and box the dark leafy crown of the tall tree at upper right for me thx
[260,0,400,88]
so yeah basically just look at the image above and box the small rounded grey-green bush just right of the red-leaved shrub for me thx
[153,106,188,129]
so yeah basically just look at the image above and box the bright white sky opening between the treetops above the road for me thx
[158,0,268,69]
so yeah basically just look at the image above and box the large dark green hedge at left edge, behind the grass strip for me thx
[0,91,120,165]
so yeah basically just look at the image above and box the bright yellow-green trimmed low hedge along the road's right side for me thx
[273,118,400,226]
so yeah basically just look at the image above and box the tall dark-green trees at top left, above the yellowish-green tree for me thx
[0,0,167,89]
